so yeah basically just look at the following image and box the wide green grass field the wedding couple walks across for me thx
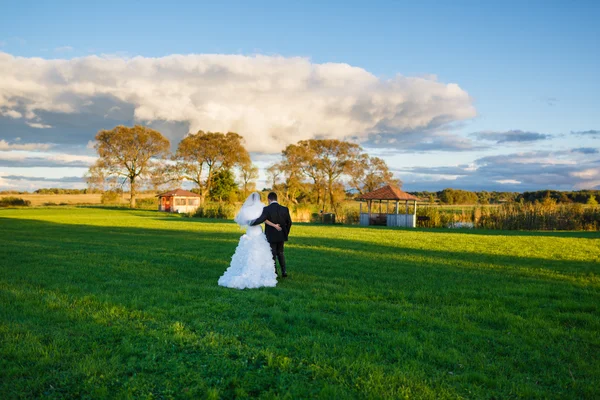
[0,208,600,399]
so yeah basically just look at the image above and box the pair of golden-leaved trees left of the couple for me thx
[86,125,258,207]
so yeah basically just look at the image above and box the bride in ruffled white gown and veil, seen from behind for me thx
[219,192,281,289]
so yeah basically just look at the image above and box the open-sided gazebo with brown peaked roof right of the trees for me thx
[356,185,420,228]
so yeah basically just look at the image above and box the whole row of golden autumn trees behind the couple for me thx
[86,125,401,209]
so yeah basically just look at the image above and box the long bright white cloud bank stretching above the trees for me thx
[0,52,476,152]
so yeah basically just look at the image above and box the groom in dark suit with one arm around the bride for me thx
[252,192,292,278]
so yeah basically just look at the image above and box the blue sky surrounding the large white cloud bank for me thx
[0,1,600,190]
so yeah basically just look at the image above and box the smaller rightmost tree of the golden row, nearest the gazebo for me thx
[348,154,402,194]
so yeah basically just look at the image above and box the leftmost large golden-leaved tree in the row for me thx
[87,125,170,208]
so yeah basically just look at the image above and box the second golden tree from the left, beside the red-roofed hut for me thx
[174,131,250,201]
